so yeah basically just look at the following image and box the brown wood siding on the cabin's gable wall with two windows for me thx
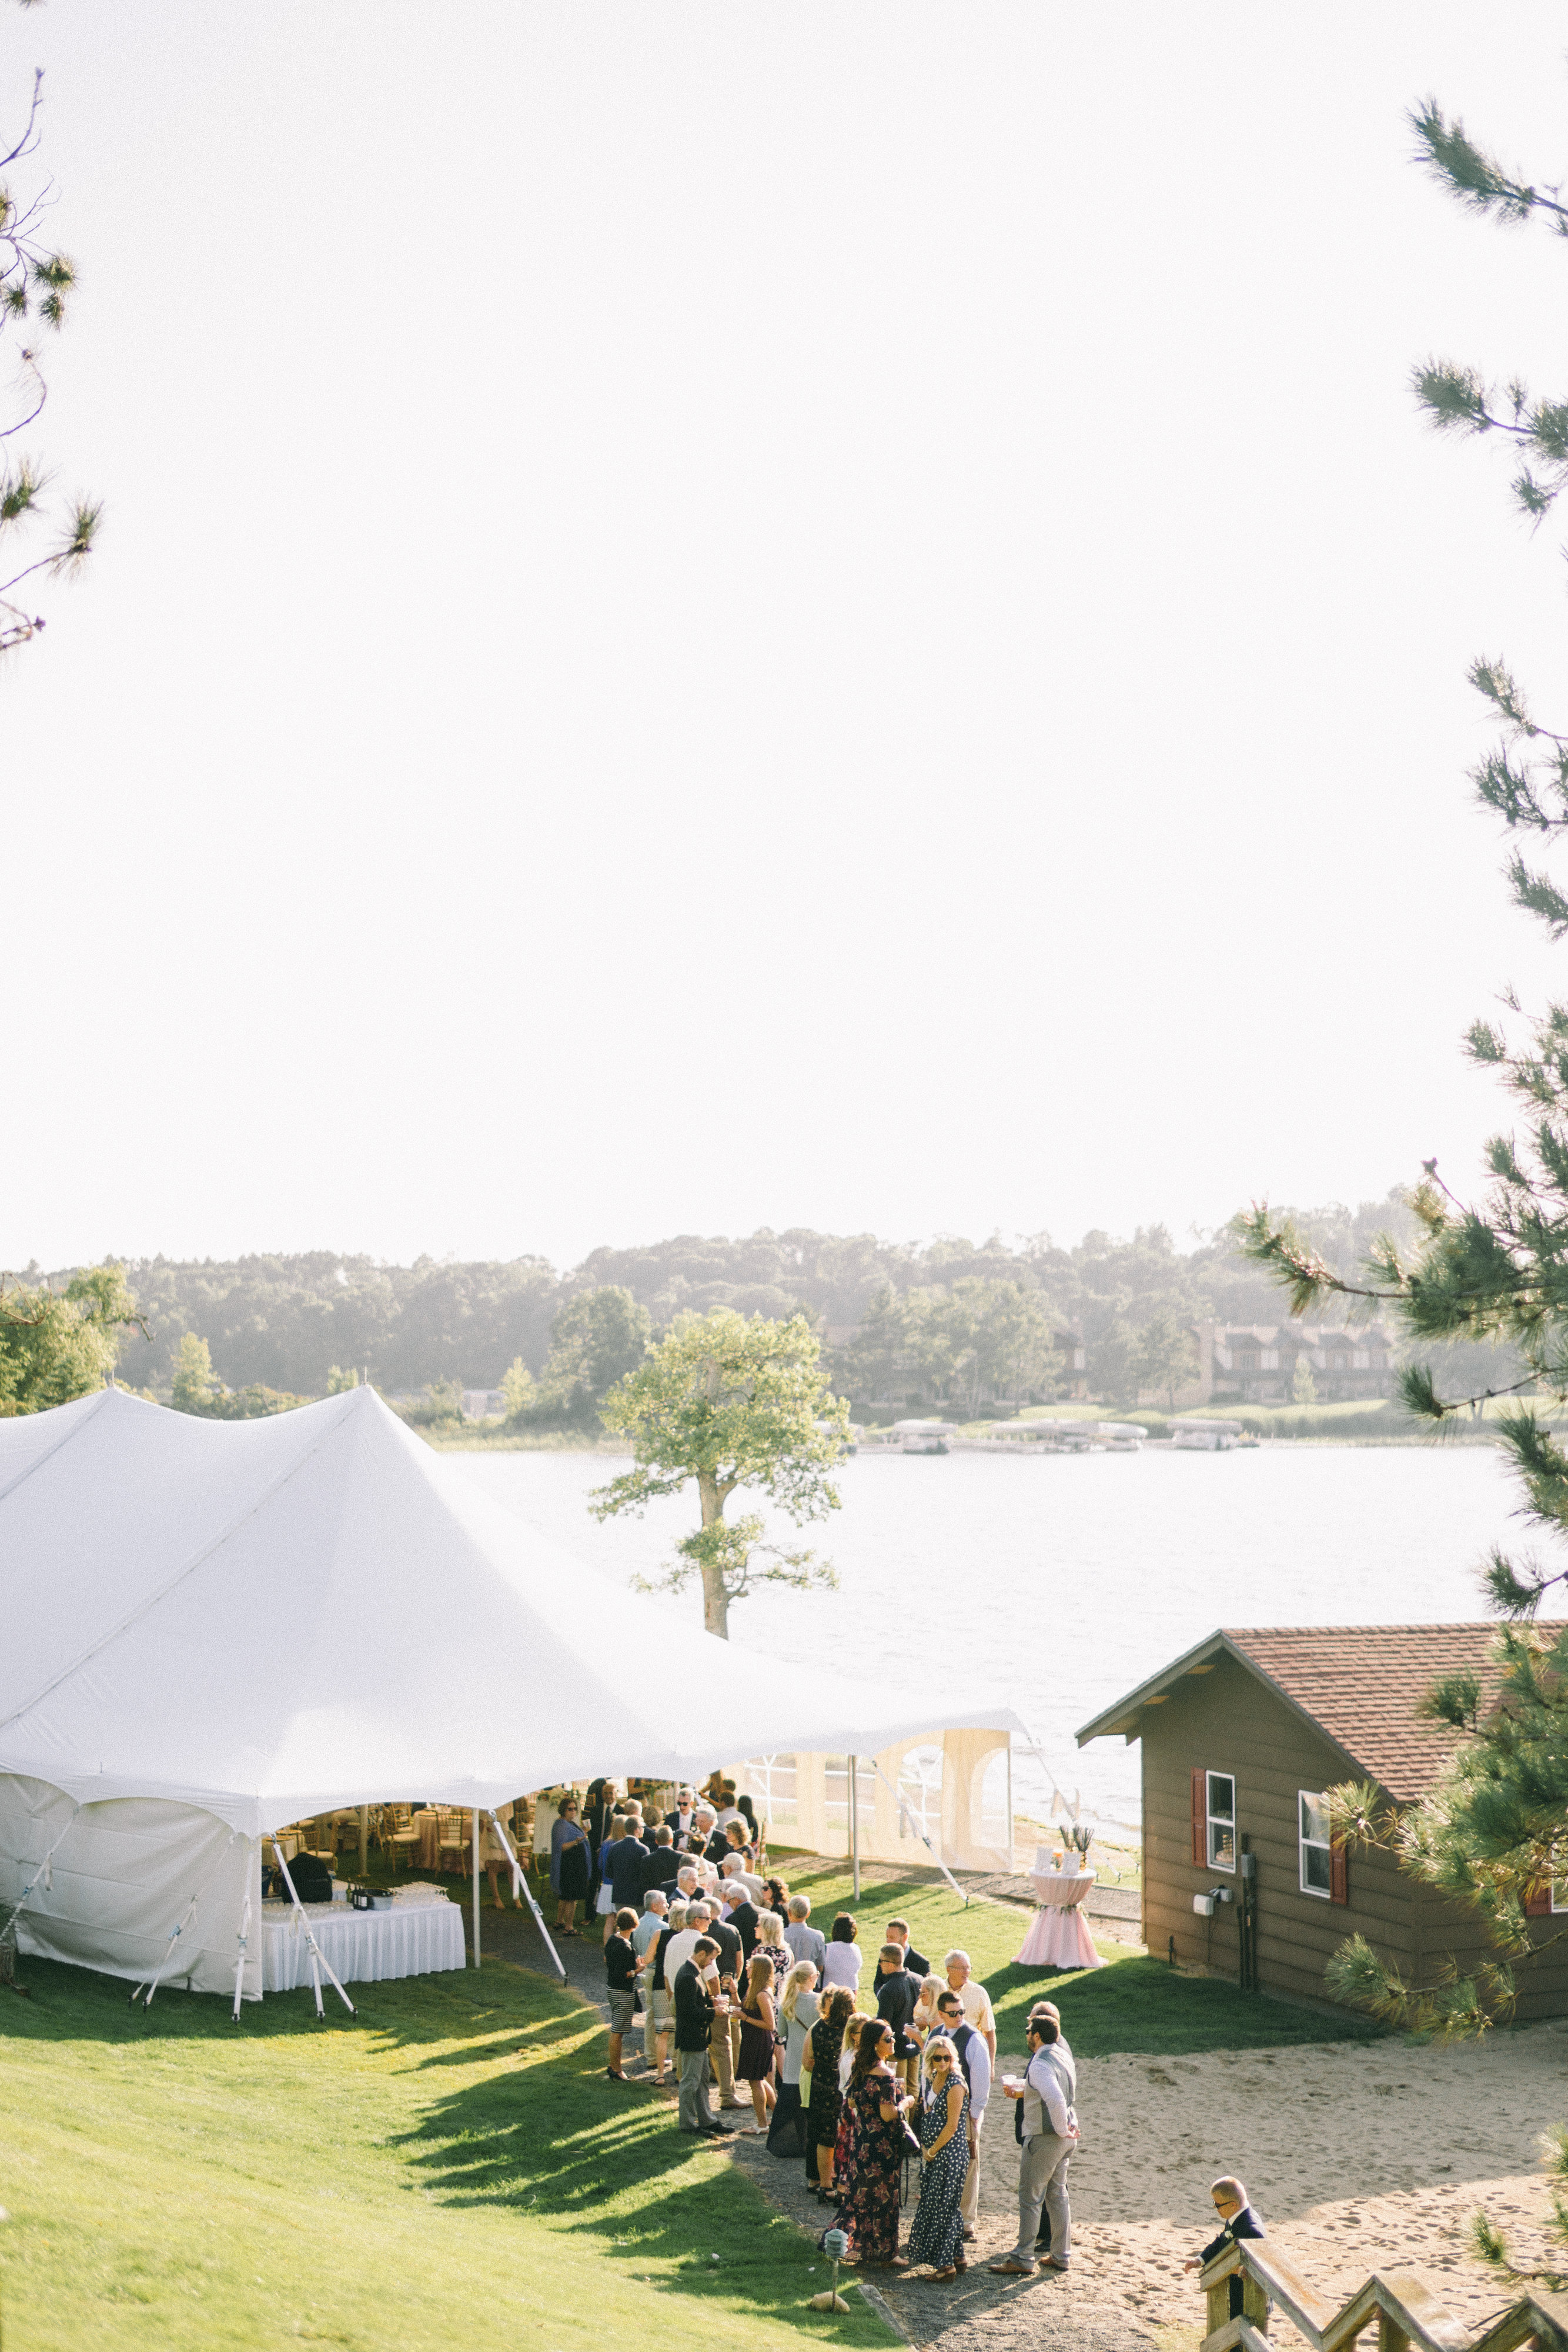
[1142,1658,1422,2002]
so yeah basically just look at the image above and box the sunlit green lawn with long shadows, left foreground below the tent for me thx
[0,1959,888,2352]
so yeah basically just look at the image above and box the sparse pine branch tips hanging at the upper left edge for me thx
[0,71,103,654]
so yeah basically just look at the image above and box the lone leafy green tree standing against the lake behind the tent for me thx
[593,1308,848,1639]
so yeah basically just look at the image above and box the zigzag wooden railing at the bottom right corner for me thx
[1199,2237,1568,2352]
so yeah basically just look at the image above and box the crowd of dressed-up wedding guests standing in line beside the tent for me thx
[564,1783,1076,2281]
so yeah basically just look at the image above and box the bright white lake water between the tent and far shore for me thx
[449,1444,1519,1825]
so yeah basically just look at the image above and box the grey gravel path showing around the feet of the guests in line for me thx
[484,1905,1161,2352]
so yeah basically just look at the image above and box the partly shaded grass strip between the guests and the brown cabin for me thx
[776,1853,1375,2058]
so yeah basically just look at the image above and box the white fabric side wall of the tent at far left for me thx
[0,1773,261,2002]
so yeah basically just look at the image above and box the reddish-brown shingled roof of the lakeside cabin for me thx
[1225,1621,1561,1802]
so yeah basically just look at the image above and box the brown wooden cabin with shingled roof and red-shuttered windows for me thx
[1079,1623,1568,2020]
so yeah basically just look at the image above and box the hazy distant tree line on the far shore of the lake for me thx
[0,1195,1523,1428]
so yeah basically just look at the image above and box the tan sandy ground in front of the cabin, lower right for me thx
[950,2023,1568,2352]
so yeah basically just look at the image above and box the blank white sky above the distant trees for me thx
[0,0,1568,1265]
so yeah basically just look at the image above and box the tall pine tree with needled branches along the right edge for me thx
[1239,101,1568,2286]
